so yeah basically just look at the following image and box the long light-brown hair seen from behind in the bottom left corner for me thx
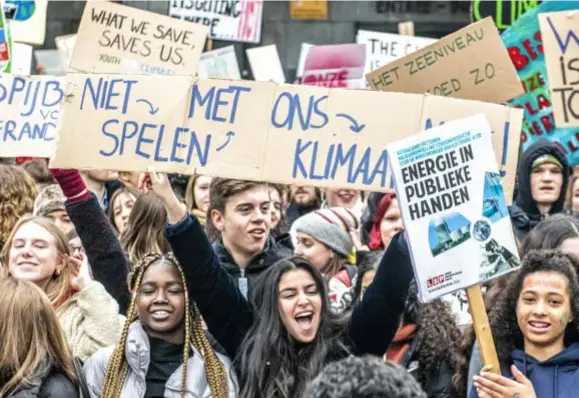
[0,277,77,397]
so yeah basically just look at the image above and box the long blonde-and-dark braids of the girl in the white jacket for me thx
[101,253,228,398]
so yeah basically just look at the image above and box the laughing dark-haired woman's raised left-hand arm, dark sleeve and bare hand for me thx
[142,172,253,358]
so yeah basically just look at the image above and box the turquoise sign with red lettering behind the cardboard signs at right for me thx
[502,1,579,165]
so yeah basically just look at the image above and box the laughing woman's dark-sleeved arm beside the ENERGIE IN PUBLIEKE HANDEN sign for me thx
[348,234,413,356]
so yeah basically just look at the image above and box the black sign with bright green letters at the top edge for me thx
[471,0,541,32]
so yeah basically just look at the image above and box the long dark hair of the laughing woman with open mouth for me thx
[236,257,348,398]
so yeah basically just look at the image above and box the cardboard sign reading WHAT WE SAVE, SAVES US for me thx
[70,1,207,76]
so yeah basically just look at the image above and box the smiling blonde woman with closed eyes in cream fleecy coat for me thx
[1,217,124,361]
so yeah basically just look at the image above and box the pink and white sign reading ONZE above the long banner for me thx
[302,44,366,88]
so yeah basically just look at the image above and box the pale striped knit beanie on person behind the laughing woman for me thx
[292,207,358,257]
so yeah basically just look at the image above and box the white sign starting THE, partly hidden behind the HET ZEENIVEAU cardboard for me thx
[356,30,436,73]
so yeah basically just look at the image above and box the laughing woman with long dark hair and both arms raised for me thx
[141,172,412,398]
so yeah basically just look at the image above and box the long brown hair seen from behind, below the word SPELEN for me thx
[121,192,170,263]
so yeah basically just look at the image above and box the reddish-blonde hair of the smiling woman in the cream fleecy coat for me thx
[0,216,73,310]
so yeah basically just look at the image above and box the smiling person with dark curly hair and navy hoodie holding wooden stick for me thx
[469,250,579,398]
